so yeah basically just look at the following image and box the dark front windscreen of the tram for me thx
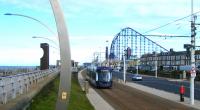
[98,70,111,82]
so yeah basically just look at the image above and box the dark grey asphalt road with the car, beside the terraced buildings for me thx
[113,72,200,100]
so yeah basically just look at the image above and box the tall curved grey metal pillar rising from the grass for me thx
[49,0,71,110]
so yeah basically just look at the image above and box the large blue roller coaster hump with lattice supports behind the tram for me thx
[110,27,168,60]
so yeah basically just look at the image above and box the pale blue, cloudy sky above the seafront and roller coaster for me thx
[0,0,200,66]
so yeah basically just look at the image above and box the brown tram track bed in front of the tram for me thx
[95,82,195,110]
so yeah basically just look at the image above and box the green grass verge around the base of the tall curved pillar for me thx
[27,74,94,110]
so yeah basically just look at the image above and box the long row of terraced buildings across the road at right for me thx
[140,49,200,70]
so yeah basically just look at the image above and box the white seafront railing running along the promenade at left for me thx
[0,69,60,104]
